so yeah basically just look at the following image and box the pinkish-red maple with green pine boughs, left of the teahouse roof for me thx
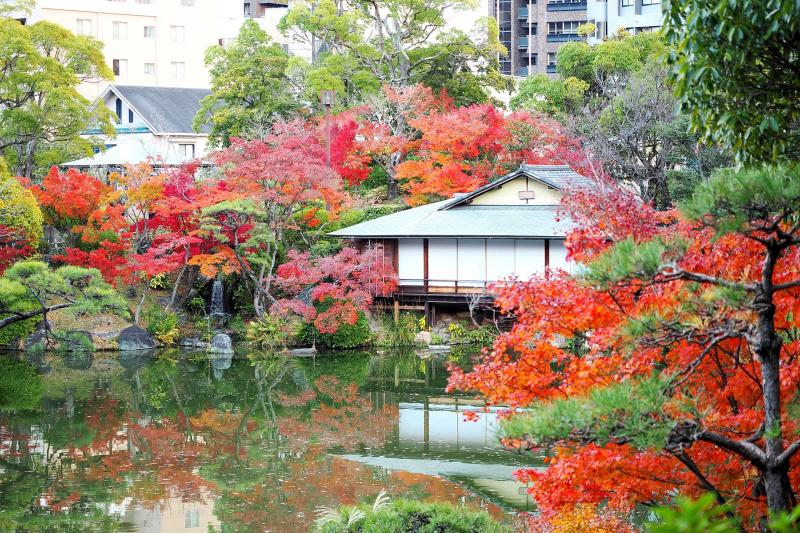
[193,121,346,317]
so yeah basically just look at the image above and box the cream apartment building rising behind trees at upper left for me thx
[20,0,244,97]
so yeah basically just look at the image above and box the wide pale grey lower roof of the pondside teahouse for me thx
[330,200,572,238]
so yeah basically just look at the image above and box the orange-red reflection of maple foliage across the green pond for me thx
[0,376,503,532]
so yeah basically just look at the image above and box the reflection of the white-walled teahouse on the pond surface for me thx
[343,352,541,510]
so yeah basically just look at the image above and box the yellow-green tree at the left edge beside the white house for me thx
[0,18,113,177]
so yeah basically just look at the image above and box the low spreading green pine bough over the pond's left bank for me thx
[0,261,128,330]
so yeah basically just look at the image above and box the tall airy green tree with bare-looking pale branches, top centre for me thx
[281,0,507,104]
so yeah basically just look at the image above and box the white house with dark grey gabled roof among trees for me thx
[63,85,211,167]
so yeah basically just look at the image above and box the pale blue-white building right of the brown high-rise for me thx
[586,0,664,43]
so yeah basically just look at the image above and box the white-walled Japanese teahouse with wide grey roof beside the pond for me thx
[330,165,592,315]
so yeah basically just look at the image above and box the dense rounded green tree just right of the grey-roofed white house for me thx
[194,20,303,146]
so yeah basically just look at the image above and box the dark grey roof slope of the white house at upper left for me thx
[111,85,211,133]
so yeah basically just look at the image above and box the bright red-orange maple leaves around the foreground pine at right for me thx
[450,178,800,517]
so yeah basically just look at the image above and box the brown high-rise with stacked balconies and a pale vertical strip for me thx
[489,0,588,76]
